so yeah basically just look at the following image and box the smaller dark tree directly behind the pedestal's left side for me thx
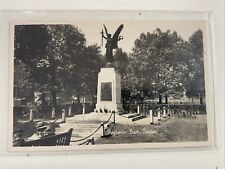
[65,44,103,100]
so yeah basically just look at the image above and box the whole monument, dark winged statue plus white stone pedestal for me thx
[95,25,123,113]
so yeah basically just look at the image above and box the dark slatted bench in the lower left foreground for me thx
[21,128,73,147]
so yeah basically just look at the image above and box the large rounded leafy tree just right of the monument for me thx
[127,29,188,103]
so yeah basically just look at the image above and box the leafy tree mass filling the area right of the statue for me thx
[123,28,204,103]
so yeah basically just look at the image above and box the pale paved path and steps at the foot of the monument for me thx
[53,112,156,145]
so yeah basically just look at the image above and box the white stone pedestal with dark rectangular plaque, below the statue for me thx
[95,67,124,113]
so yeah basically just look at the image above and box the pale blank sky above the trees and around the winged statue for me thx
[71,20,206,53]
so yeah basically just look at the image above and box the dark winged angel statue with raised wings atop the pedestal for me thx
[101,24,123,66]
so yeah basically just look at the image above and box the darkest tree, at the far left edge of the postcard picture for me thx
[14,25,50,105]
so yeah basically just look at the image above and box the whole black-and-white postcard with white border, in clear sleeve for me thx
[9,13,214,151]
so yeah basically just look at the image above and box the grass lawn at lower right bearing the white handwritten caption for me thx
[95,115,208,144]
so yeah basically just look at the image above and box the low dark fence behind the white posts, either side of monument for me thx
[13,103,206,119]
